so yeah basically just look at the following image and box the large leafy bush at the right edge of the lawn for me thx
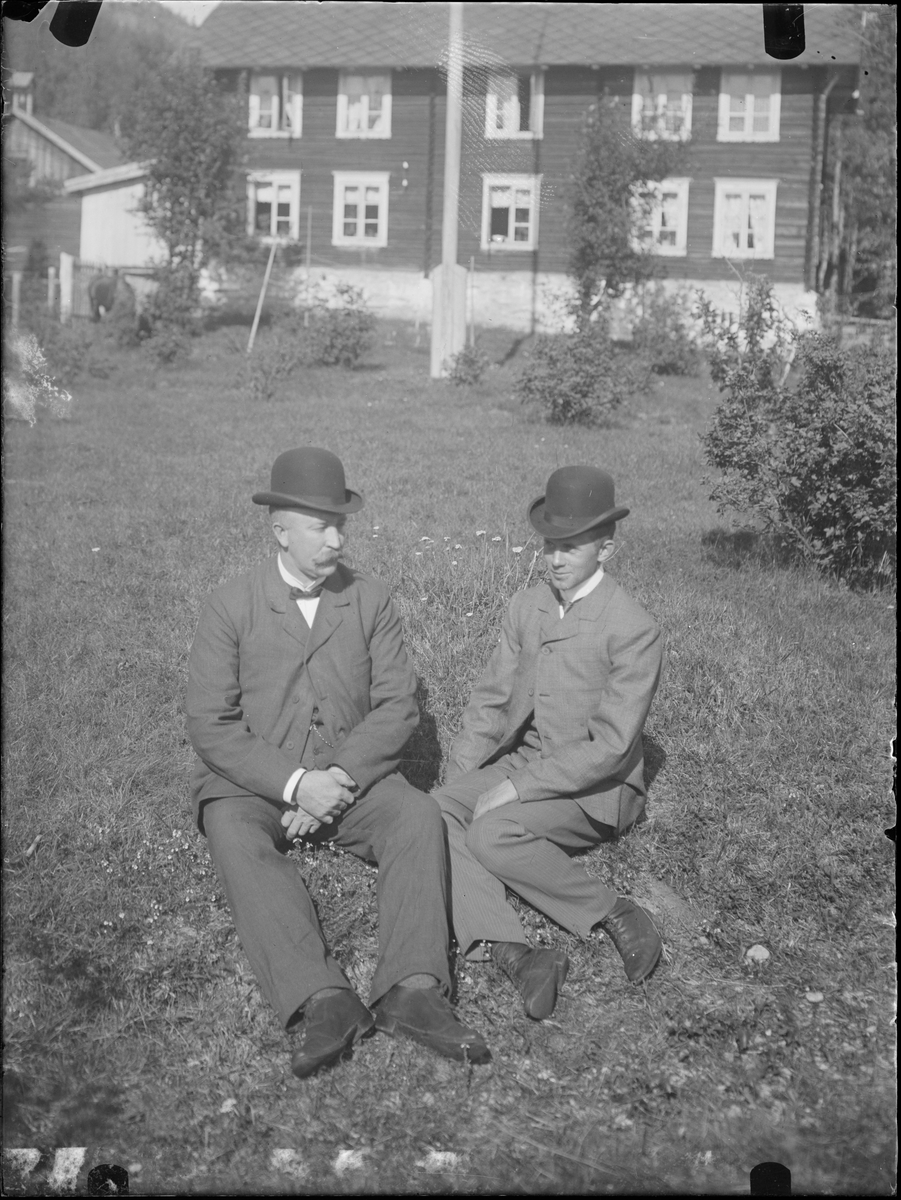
[701,281,897,586]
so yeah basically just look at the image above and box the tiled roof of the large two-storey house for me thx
[199,0,860,68]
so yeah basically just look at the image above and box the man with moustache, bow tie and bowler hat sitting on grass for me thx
[187,446,491,1078]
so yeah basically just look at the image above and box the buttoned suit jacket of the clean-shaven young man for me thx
[446,575,662,829]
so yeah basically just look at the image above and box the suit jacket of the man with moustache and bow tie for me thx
[187,556,419,825]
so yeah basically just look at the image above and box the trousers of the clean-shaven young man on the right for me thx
[432,758,617,960]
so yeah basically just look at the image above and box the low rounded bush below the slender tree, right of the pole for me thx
[515,310,644,425]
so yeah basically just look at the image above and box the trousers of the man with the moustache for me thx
[200,775,450,1028]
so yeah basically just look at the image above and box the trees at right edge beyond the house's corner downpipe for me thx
[821,5,897,317]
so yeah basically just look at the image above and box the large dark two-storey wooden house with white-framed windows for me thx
[200,0,859,329]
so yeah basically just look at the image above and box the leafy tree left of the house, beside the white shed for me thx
[122,52,245,336]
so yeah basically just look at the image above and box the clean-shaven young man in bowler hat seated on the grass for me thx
[434,467,662,1020]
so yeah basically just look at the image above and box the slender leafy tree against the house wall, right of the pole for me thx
[569,96,686,318]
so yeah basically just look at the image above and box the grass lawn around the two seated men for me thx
[4,314,895,1195]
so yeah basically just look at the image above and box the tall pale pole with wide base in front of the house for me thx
[431,0,467,379]
